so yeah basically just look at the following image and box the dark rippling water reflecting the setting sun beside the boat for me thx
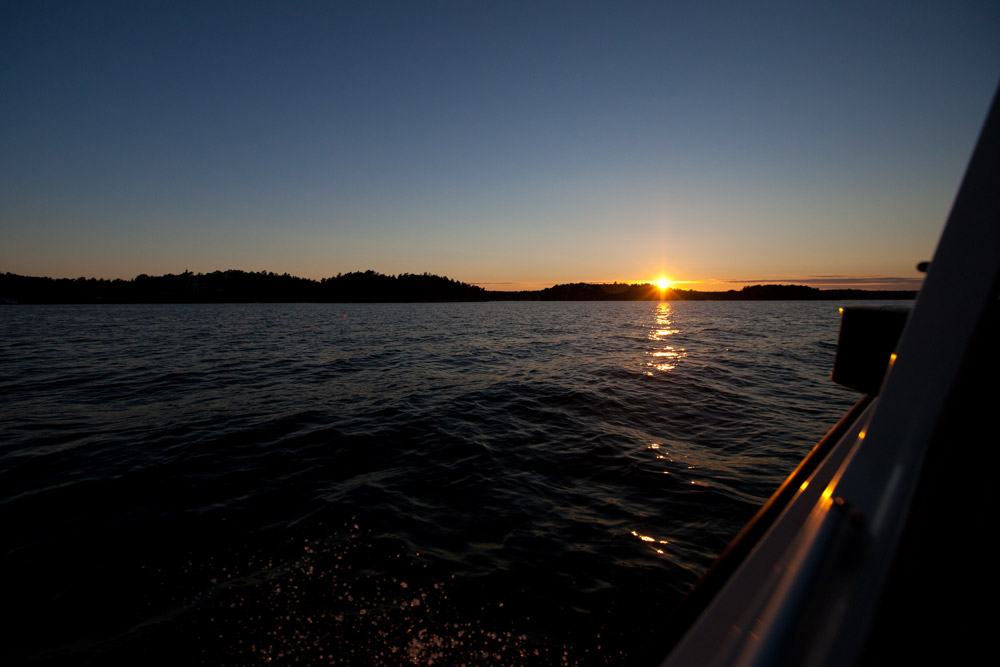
[0,302,856,665]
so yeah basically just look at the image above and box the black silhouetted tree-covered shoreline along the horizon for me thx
[0,270,917,305]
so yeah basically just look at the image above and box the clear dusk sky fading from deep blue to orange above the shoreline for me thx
[0,0,1000,289]
